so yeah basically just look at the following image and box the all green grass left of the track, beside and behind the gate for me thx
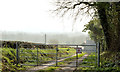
[1,48,75,71]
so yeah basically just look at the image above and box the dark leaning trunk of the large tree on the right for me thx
[97,3,120,52]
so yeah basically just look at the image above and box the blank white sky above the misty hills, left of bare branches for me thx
[0,0,89,33]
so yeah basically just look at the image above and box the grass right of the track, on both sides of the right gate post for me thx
[78,53,120,72]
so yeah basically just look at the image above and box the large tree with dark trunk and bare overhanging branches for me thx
[53,0,120,51]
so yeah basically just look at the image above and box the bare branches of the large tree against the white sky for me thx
[53,0,96,21]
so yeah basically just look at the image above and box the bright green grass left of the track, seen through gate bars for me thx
[20,48,75,64]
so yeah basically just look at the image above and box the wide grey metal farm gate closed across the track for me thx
[16,43,100,67]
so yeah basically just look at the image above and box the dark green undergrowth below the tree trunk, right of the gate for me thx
[100,51,120,71]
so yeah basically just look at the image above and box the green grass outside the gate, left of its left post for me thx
[2,48,25,71]
